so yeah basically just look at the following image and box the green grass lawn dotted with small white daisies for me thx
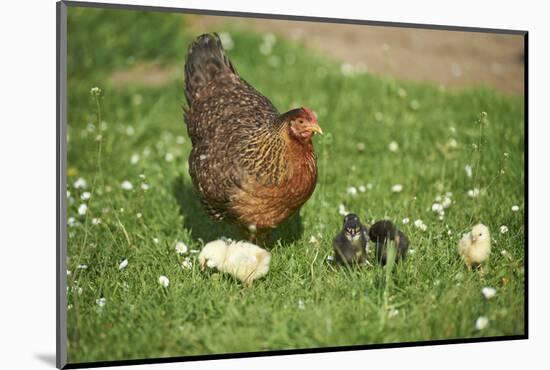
[67,8,525,362]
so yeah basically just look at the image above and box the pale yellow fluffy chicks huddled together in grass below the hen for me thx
[199,239,271,287]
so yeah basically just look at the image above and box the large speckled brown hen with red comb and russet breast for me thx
[184,34,322,240]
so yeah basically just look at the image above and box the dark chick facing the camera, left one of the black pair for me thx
[332,213,369,265]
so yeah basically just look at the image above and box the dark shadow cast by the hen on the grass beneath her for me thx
[173,175,304,248]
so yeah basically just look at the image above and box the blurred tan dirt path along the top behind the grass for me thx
[189,16,524,95]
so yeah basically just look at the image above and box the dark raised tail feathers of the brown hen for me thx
[185,33,237,106]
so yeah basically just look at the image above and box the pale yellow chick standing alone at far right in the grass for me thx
[458,224,491,269]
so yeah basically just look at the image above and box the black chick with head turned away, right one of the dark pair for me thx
[369,220,409,265]
